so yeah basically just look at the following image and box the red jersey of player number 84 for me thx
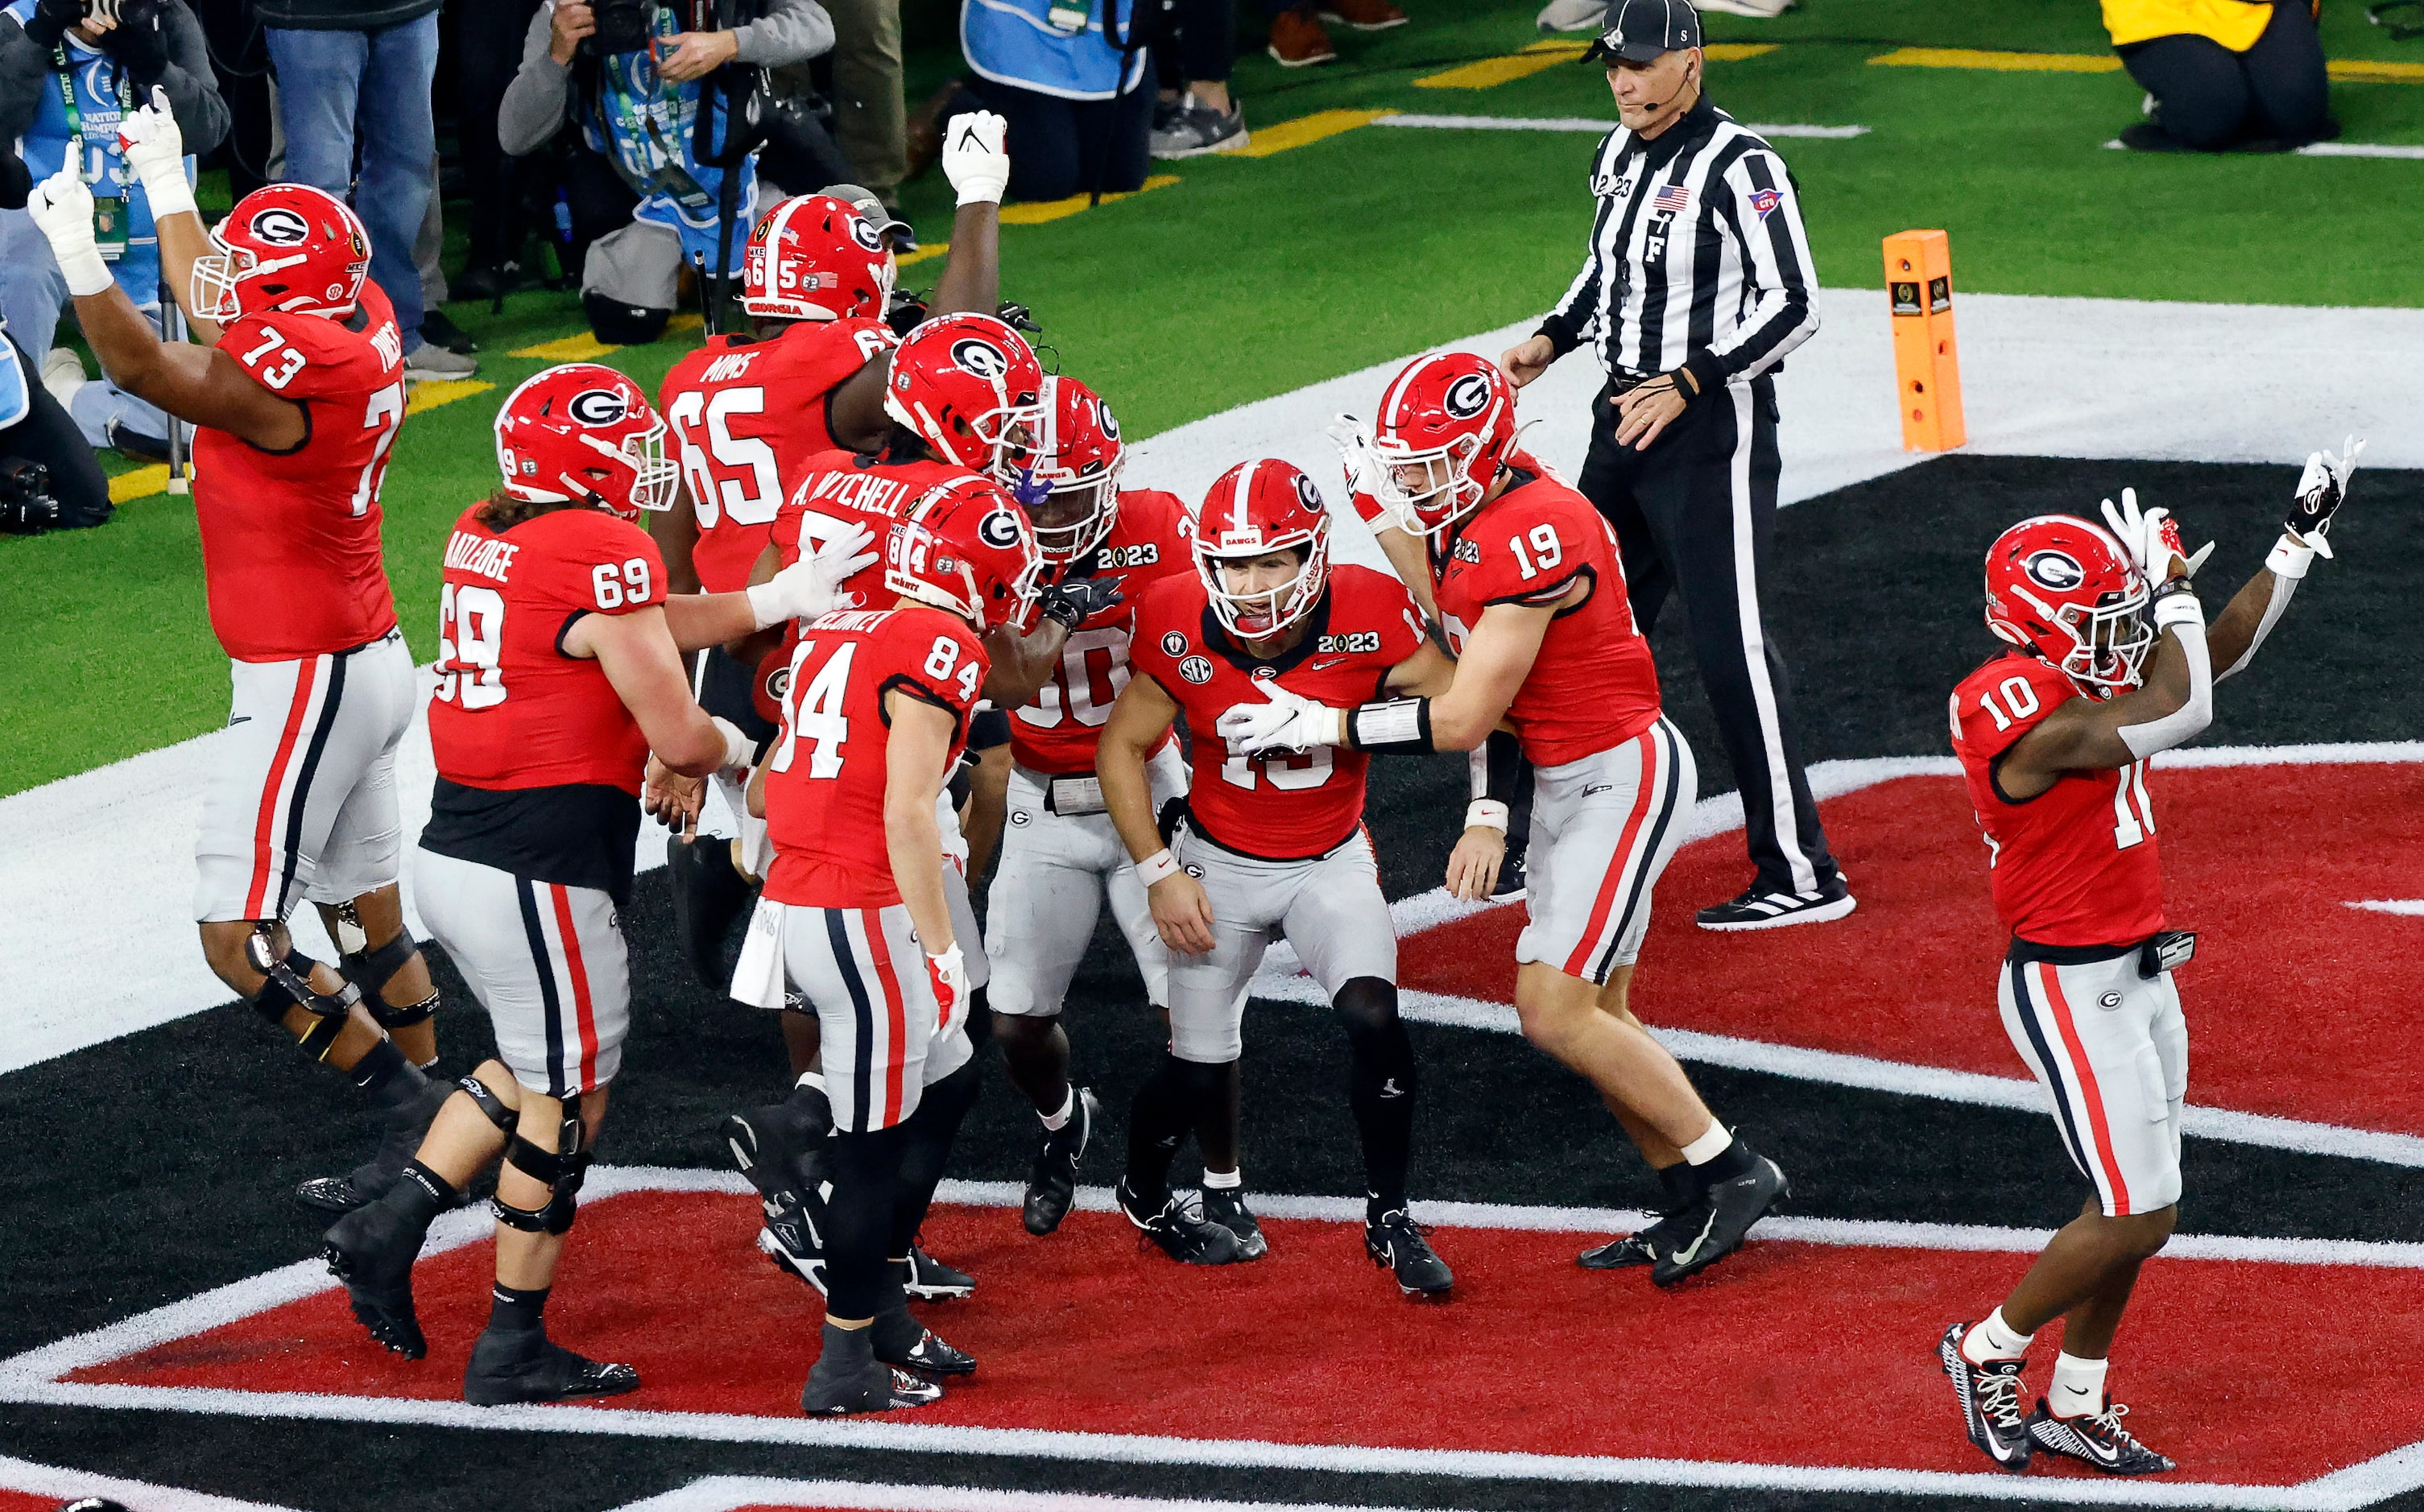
[766,605,987,909]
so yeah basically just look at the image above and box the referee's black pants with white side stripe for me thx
[1578,378,1835,892]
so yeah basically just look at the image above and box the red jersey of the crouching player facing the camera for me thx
[1130,564,1423,860]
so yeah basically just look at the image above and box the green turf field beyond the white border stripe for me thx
[0,0,2424,795]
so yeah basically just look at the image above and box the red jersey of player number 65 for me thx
[657,320,892,593]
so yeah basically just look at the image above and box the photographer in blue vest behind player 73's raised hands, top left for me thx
[0,0,228,461]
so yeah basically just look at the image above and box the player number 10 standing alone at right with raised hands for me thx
[1937,455,2364,1476]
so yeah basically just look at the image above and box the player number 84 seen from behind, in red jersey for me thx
[744,477,1042,1415]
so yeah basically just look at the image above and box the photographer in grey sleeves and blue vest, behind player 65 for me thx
[497,0,834,344]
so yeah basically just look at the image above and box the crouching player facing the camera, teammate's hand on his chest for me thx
[1096,461,1454,1296]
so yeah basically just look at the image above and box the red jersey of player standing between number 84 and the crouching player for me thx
[1011,490,1195,775]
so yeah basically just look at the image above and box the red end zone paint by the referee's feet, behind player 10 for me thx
[1399,763,2424,1134]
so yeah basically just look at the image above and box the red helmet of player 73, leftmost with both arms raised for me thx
[189,184,371,322]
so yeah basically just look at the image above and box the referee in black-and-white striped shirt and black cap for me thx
[1498,0,1855,931]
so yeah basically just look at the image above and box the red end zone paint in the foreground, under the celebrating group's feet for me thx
[70,1192,2424,1483]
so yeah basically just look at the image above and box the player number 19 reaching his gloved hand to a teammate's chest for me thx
[1219,351,1784,1287]
